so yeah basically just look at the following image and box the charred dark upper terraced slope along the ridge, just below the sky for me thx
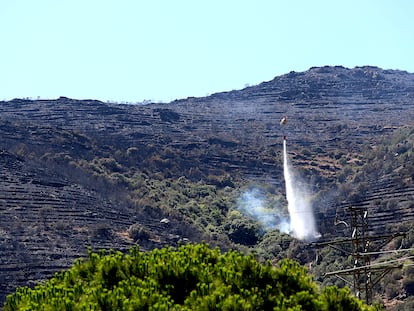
[1,67,414,183]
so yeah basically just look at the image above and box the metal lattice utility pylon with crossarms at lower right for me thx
[314,207,405,304]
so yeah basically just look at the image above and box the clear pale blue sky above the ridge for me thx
[0,0,414,102]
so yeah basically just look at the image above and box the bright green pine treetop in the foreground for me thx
[4,243,373,311]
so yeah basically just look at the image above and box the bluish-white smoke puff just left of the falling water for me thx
[237,187,290,233]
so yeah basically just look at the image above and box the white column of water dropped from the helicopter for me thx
[283,139,320,241]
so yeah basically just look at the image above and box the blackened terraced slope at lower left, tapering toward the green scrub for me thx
[0,151,204,300]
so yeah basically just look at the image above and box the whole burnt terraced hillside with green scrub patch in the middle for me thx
[0,66,414,300]
